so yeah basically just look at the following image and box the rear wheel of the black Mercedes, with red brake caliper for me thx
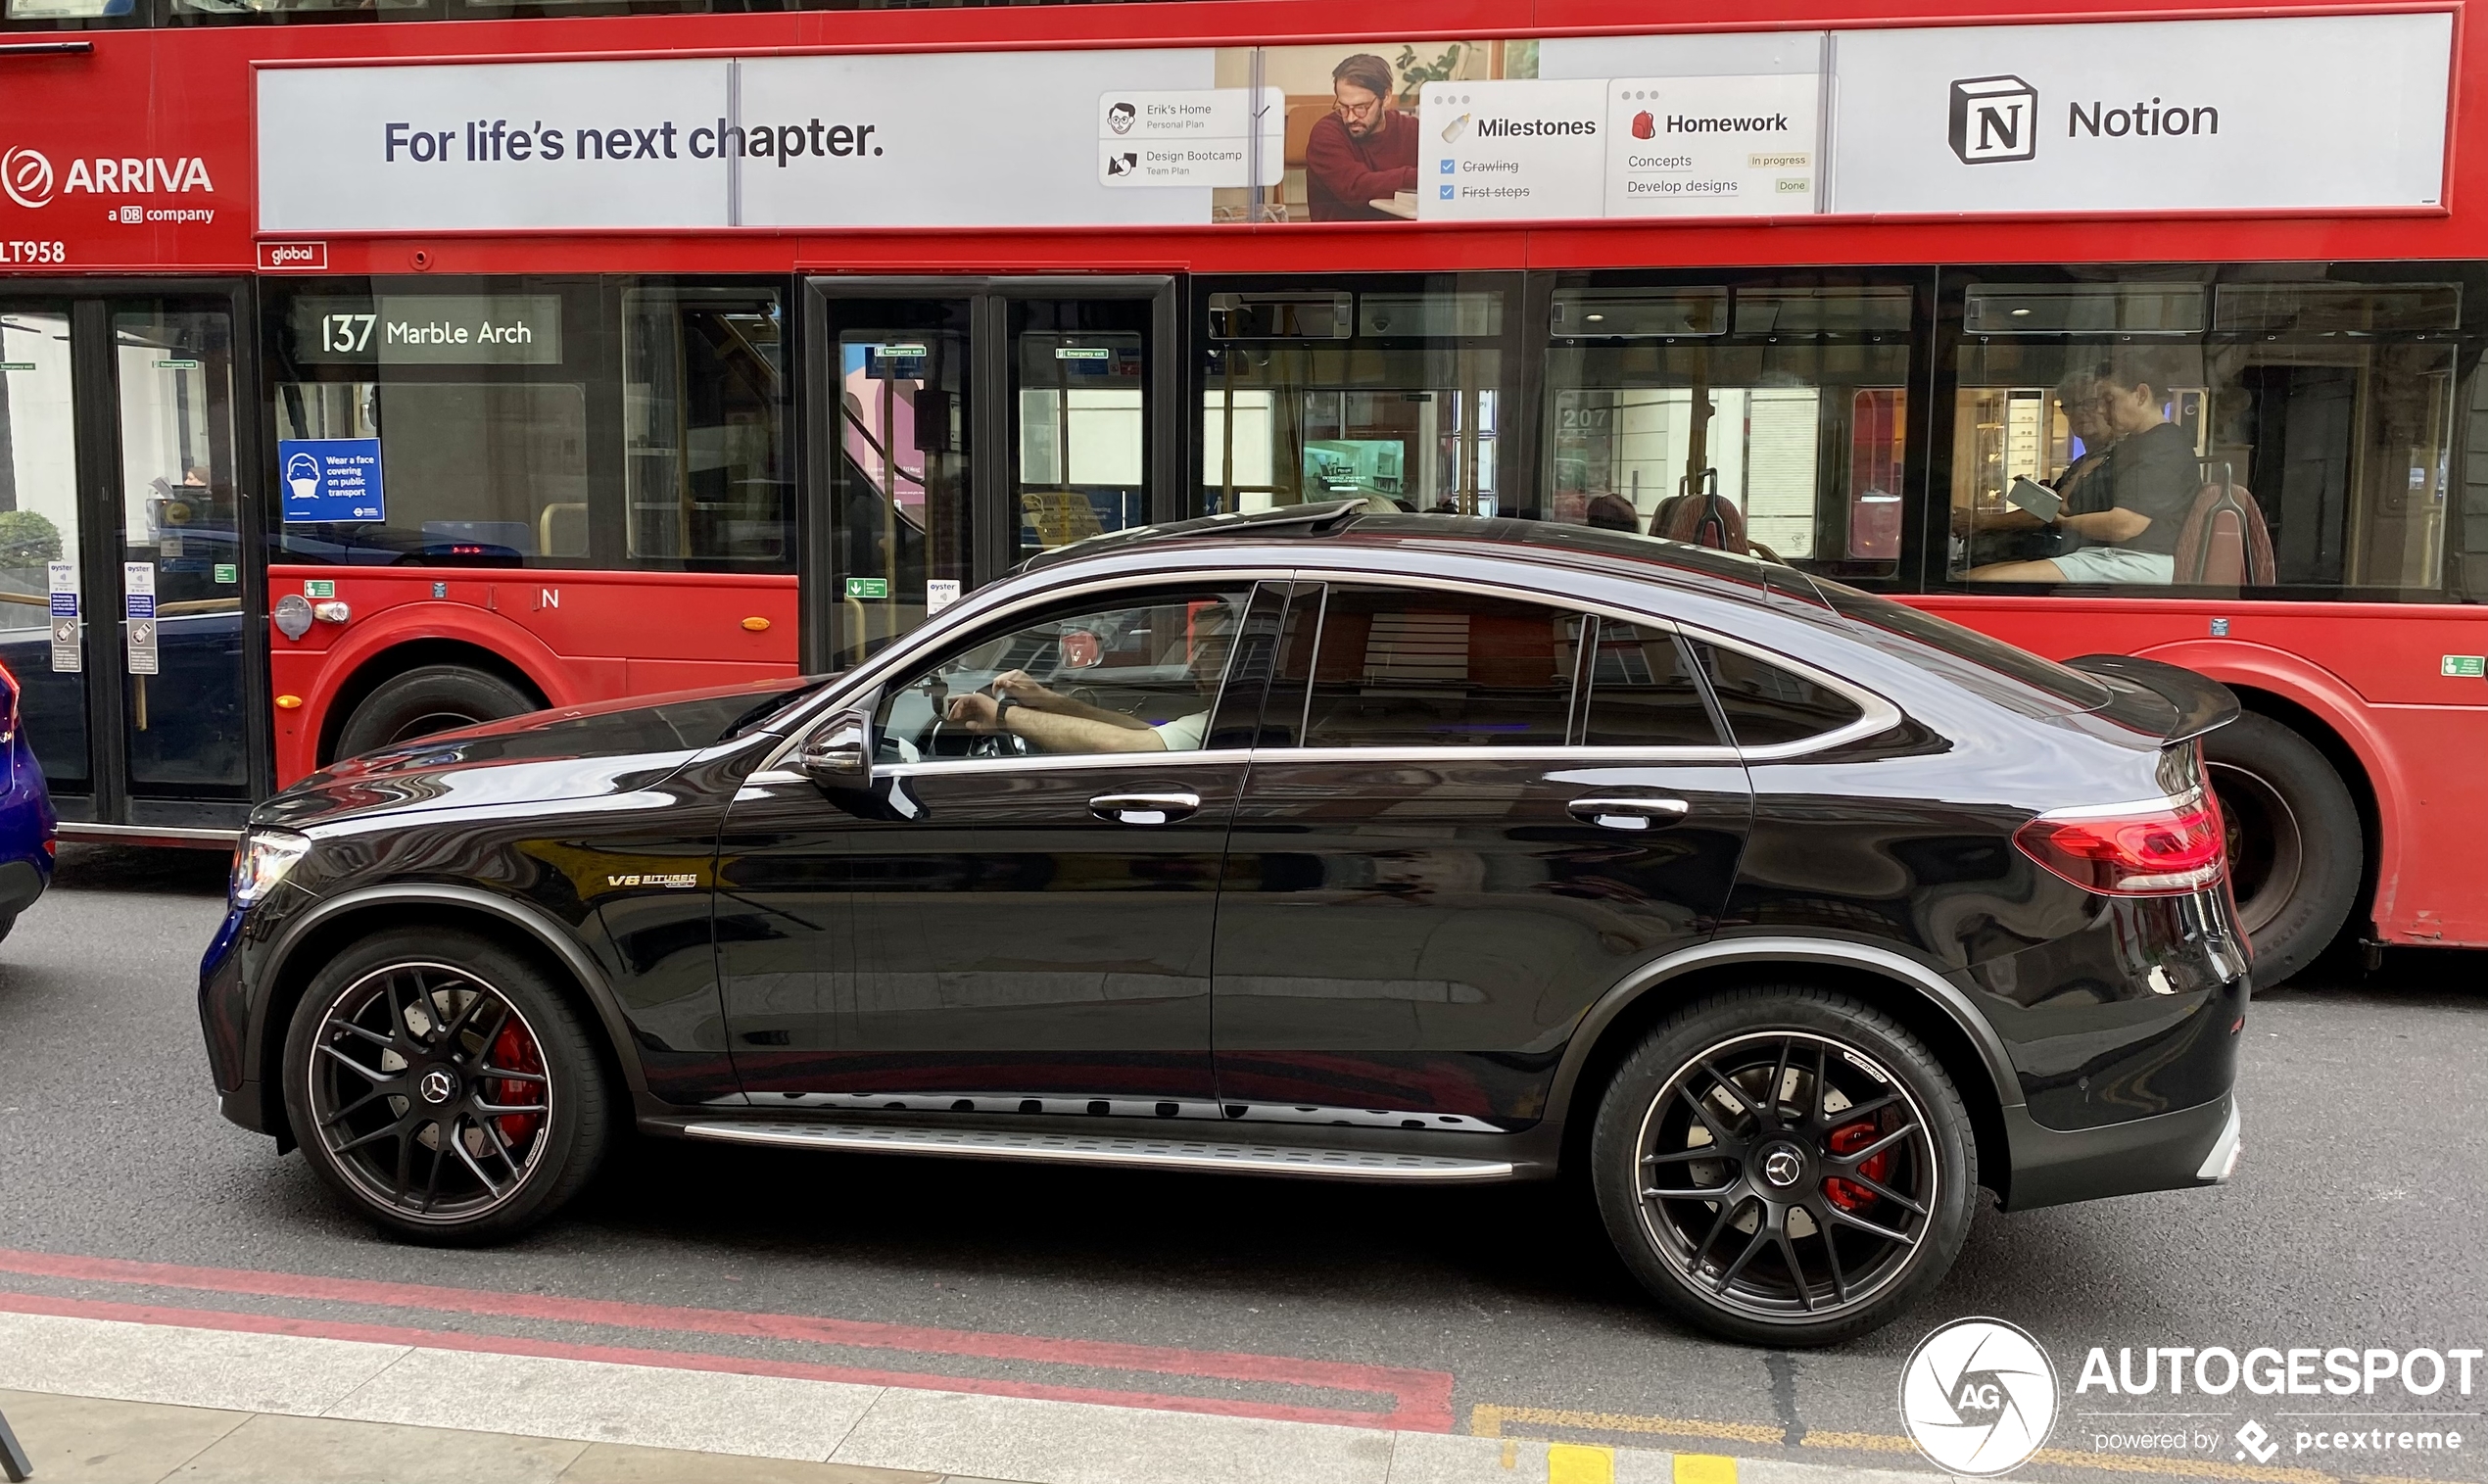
[1590,986,1978,1347]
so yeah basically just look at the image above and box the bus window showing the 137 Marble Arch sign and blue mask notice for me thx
[268,279,607,568]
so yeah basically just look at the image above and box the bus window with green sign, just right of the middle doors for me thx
[1202,274,1517,515]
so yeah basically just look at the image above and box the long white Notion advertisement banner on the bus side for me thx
[257,13,2453,234]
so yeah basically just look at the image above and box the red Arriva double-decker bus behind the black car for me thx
[0,0,2488,983]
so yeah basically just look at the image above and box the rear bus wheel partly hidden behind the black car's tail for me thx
[2202,712,2367,988]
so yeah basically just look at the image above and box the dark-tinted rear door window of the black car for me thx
[1271,585,1582,747]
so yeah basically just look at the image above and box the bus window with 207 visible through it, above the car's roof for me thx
[1543,274,1913,578]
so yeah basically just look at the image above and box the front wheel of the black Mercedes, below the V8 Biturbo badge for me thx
[284,929,614,1245]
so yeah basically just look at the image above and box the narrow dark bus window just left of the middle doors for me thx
[622,286,793,573]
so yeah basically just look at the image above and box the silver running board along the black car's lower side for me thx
[682,1123,1512,1182]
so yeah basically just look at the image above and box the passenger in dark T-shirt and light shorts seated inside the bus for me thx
[1968,354,2202,583]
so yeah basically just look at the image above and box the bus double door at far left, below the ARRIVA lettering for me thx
[0,284,268,844]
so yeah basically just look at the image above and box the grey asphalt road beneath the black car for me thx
[0,849,2488,1479]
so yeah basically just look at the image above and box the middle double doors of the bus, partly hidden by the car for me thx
[803,276,1182,670]
